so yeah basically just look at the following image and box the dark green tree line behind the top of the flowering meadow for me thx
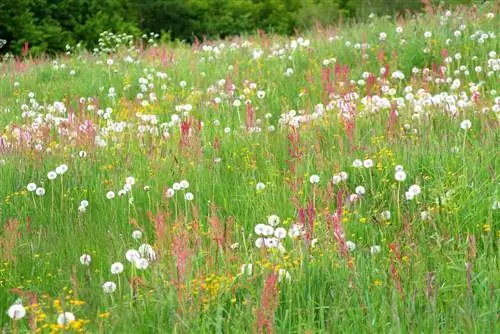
[0,0,473,54]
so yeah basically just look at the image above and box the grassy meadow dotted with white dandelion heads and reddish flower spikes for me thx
[0,3,500,333]
